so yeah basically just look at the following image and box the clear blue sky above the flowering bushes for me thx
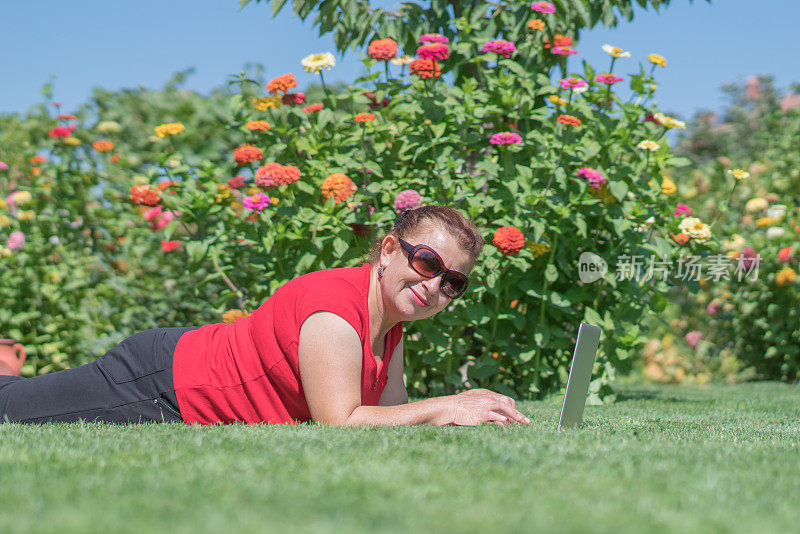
[0,0,800,118]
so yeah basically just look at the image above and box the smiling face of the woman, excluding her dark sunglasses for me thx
[379,226,471,321]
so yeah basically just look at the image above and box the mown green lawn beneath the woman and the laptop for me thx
[0,383,800,534]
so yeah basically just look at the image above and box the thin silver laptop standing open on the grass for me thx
[557,323,600,429]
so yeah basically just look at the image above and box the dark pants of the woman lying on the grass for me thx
[0,326,199,423]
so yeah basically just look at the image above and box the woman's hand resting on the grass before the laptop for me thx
[447,389,531,426]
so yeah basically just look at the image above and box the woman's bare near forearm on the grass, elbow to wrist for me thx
[342,397,452,426]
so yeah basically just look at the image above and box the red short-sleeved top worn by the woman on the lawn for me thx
[172,263,403,424]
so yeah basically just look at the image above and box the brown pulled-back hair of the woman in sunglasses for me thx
[363,206,484,268]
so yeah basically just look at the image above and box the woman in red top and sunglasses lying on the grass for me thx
[0,206,530,426]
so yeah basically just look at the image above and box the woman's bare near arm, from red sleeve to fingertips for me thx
[298,312,529,426]
